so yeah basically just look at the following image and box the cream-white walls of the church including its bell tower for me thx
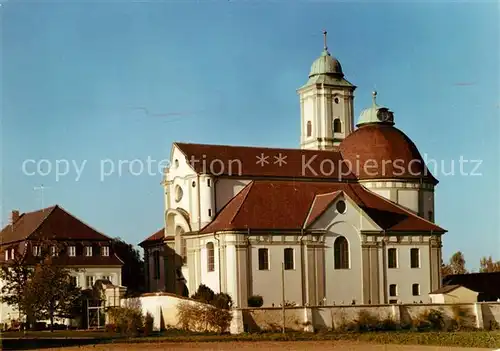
[146,38,441,307]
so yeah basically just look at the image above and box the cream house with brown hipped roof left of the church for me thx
[0,205,124,323]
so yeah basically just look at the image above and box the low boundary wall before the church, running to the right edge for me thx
[231,302,500,334]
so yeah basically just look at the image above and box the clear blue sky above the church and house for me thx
[0,0,500,268]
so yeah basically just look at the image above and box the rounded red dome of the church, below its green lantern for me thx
[339,123,438,185]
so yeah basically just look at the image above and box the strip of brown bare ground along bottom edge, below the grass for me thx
[55,341,492,351]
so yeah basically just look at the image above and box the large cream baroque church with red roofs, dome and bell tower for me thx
[140,32,446,307]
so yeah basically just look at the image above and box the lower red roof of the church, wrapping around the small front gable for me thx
[201,180,446,233]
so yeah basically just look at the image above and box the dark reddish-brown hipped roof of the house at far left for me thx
[0,205,111,245]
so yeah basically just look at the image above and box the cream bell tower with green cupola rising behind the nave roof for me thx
[297,31,356,150]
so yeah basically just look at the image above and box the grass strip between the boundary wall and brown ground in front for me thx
[2,331,500,350]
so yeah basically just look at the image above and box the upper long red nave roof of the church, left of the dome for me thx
[174,143,356,181]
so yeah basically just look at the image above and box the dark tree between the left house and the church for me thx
[113,238,145,295]
